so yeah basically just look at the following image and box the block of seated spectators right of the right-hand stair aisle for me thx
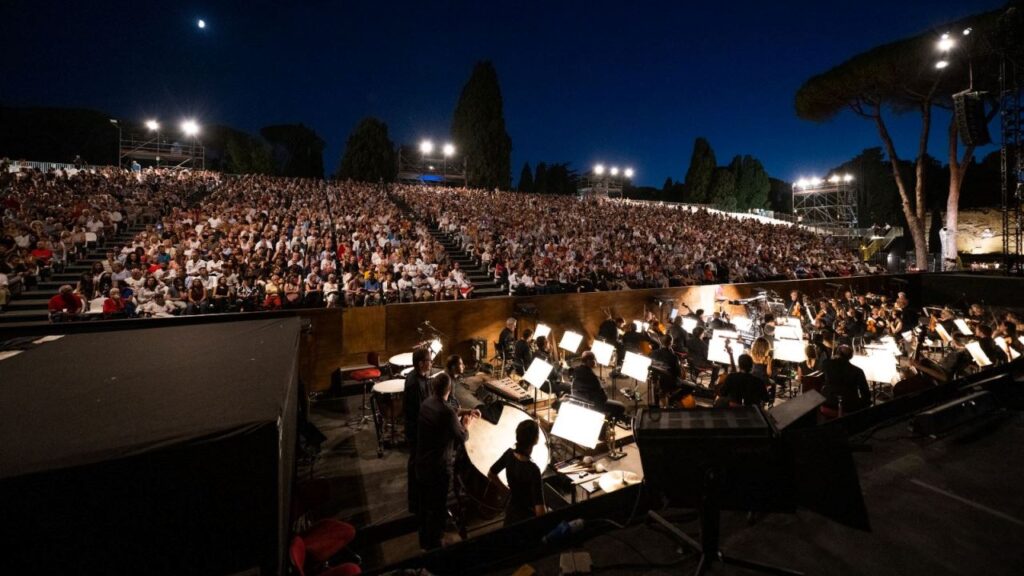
[395,186,881,294]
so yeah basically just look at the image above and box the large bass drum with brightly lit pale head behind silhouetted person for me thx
[459,404,551,519]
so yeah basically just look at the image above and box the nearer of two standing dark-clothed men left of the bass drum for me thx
[416,373,475,550]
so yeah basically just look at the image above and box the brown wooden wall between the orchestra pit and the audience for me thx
[300,276,920,392]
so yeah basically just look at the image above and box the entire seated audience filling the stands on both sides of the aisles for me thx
[0,163,878,321]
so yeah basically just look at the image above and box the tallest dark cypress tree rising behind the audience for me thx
[452,60,512,190]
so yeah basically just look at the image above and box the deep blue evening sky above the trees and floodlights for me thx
[0,0,1001,187]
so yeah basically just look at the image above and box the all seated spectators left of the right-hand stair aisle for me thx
[2,166,473,321]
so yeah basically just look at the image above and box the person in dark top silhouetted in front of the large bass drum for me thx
[487,420,547,526]
